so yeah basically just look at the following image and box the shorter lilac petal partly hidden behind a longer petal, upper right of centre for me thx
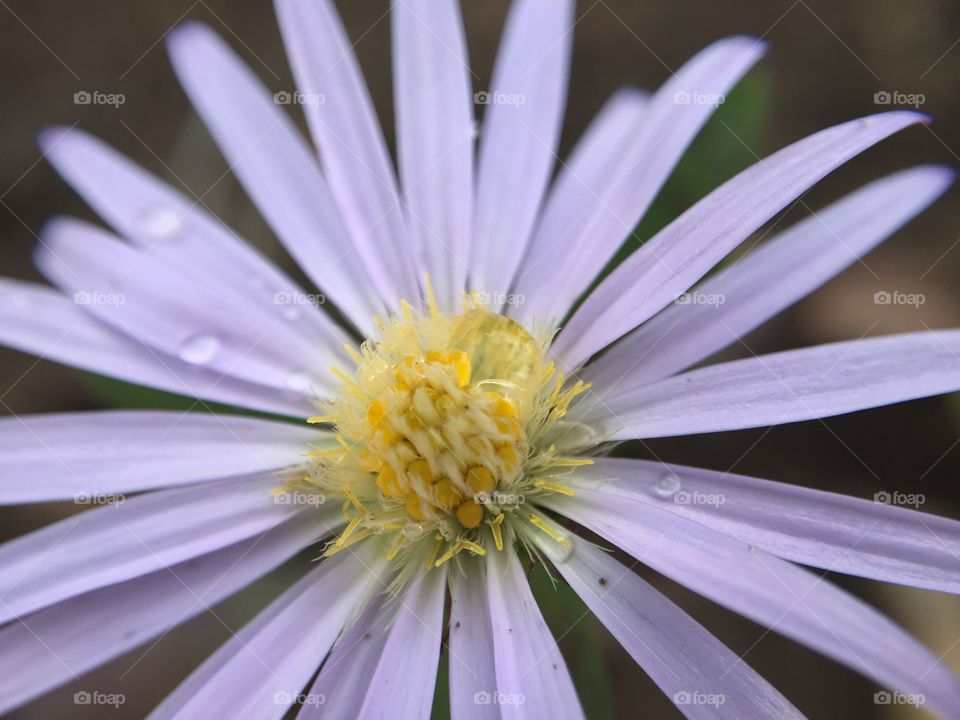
[508,88,650,324]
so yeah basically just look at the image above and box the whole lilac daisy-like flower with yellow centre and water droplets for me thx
[0,0,960,718]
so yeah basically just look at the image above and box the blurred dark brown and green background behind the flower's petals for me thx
[0,0,960,719]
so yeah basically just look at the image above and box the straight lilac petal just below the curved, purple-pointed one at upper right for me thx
[583,166,955,392]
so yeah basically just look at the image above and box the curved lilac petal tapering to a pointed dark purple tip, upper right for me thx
[554,111,926,368]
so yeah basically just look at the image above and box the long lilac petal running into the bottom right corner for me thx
[546,486,960,716]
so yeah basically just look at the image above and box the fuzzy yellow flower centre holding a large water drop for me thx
[284,292,591,567]
